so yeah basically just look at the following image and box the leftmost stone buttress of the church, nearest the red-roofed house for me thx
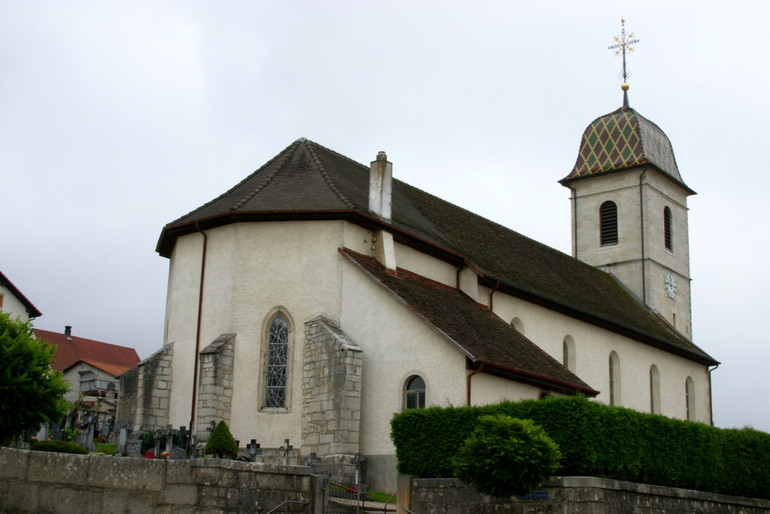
[116,343,174,433]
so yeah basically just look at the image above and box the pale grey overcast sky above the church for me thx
[0,0,770,431]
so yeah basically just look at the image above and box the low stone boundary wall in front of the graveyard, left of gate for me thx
[0,448,323,514]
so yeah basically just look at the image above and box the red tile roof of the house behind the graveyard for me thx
[34,328,139,377]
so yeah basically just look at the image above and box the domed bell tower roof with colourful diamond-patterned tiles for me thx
[561,107,694,193]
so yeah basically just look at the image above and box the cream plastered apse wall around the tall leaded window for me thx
[166,221,378,447]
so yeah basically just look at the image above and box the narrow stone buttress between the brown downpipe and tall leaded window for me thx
[195,334,235,441]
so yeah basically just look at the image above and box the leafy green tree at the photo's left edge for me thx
[0,313,69,445]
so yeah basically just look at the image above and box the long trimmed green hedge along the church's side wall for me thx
[391,397,770,499]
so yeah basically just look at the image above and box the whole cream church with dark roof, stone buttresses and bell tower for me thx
[118,90,718,491]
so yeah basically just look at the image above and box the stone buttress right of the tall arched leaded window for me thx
[302,316,363,457]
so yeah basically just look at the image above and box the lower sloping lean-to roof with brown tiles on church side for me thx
[340,249,598,396]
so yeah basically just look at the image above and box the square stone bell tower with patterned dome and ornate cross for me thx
[559,20,695,338]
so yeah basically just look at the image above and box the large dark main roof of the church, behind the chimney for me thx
[157,139,717,364]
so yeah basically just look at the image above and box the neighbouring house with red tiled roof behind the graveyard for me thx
[34,325,139,419]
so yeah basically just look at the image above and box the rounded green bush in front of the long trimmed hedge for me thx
[454,414,561,511]
